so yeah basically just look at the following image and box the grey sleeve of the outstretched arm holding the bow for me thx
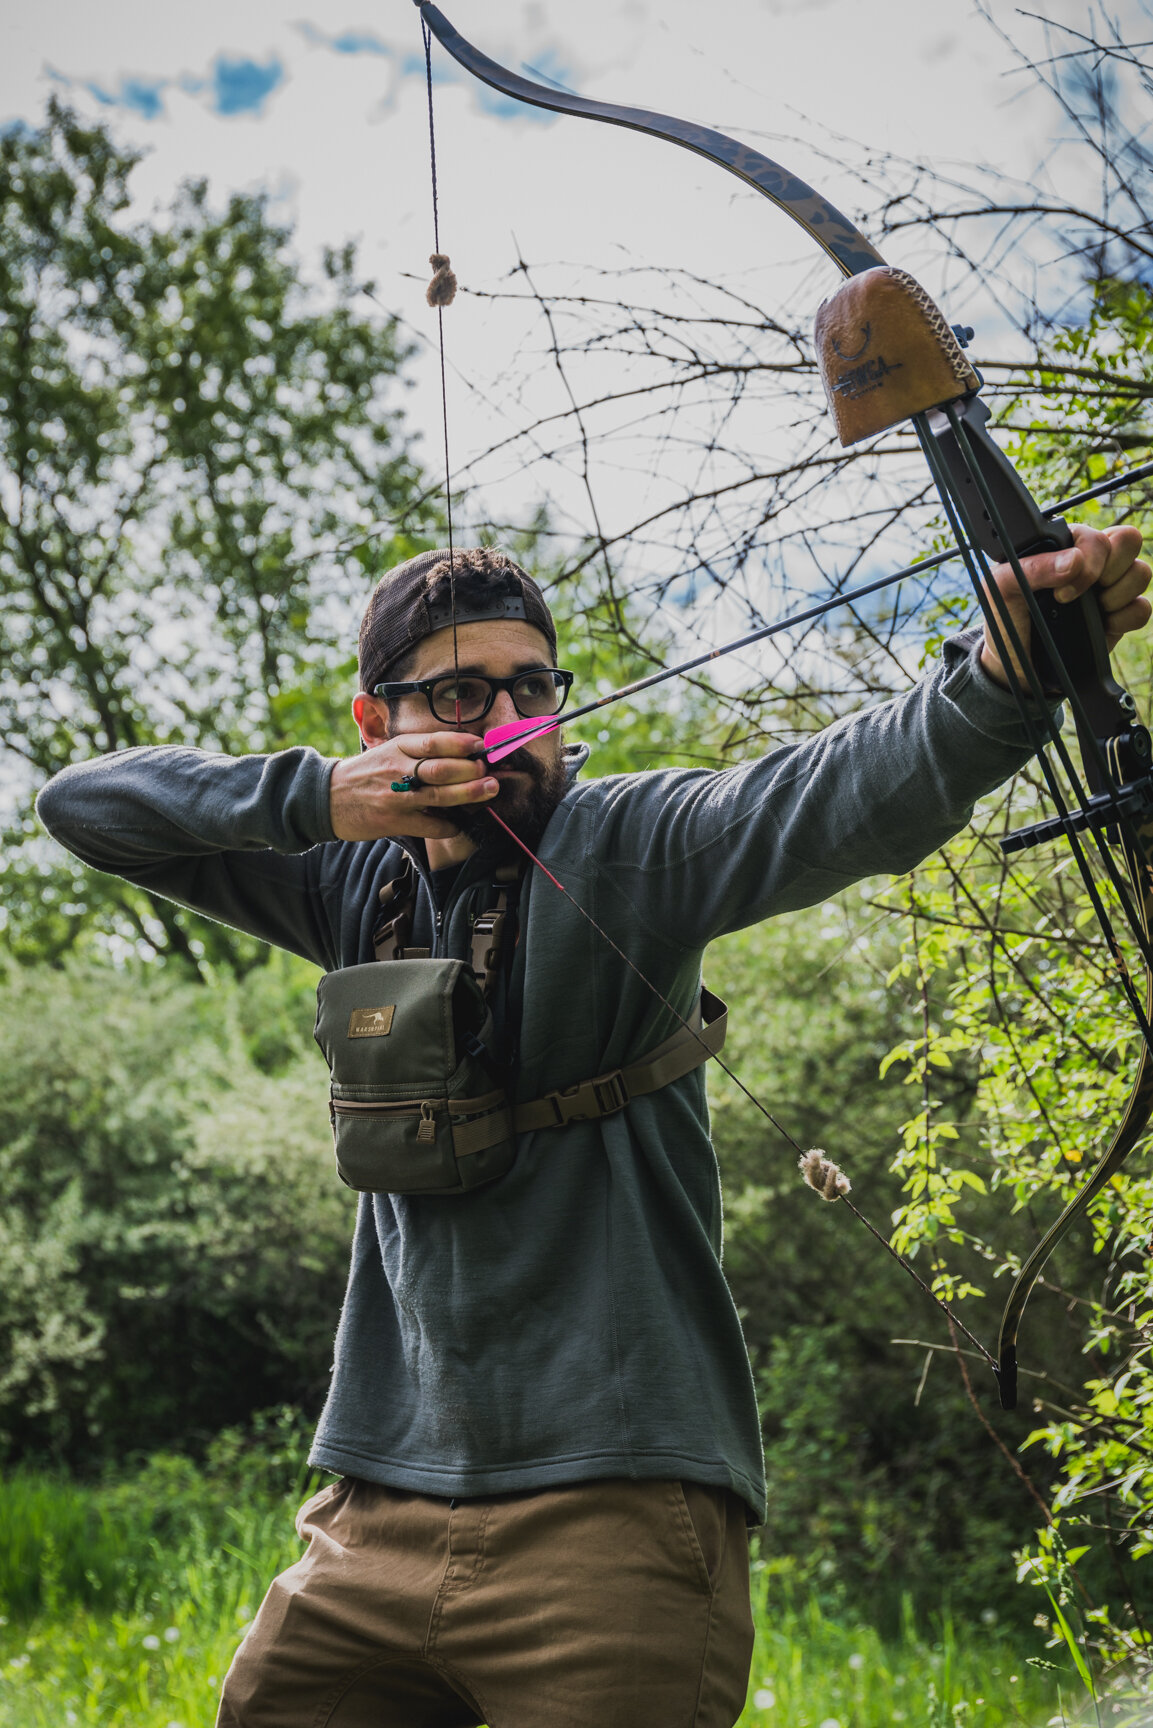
[573,632,1044,949]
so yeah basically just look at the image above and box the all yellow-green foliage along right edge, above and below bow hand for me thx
[871,276,1153,1685]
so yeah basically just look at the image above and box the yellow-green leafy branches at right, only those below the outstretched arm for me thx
[874,812,1153,1661]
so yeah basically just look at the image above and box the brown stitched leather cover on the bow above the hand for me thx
[814,264,980,444]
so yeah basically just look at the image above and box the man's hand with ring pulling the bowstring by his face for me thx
[328,733,500,840]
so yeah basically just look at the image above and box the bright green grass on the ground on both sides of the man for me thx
[0,1419,1150,1728]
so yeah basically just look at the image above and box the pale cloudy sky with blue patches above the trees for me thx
[0,0,1148,594]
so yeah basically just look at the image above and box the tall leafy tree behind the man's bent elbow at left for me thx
[0,104,437,966]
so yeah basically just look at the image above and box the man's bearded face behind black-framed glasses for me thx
[368,619,567,848]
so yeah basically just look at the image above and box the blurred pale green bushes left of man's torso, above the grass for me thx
[0,964,353,1462]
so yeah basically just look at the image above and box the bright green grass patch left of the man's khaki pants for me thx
[0,1408,318,1728]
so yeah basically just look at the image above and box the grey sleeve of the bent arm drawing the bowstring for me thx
[36,748,347,966]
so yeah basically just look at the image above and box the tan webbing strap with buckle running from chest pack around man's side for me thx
[449,990,728,1154]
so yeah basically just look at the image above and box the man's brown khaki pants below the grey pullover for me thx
[216,1477,752,1728]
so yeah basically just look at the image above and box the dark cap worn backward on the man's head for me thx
[360,546,557,695]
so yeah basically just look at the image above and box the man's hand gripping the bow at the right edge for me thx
[980,522,1153,689]
